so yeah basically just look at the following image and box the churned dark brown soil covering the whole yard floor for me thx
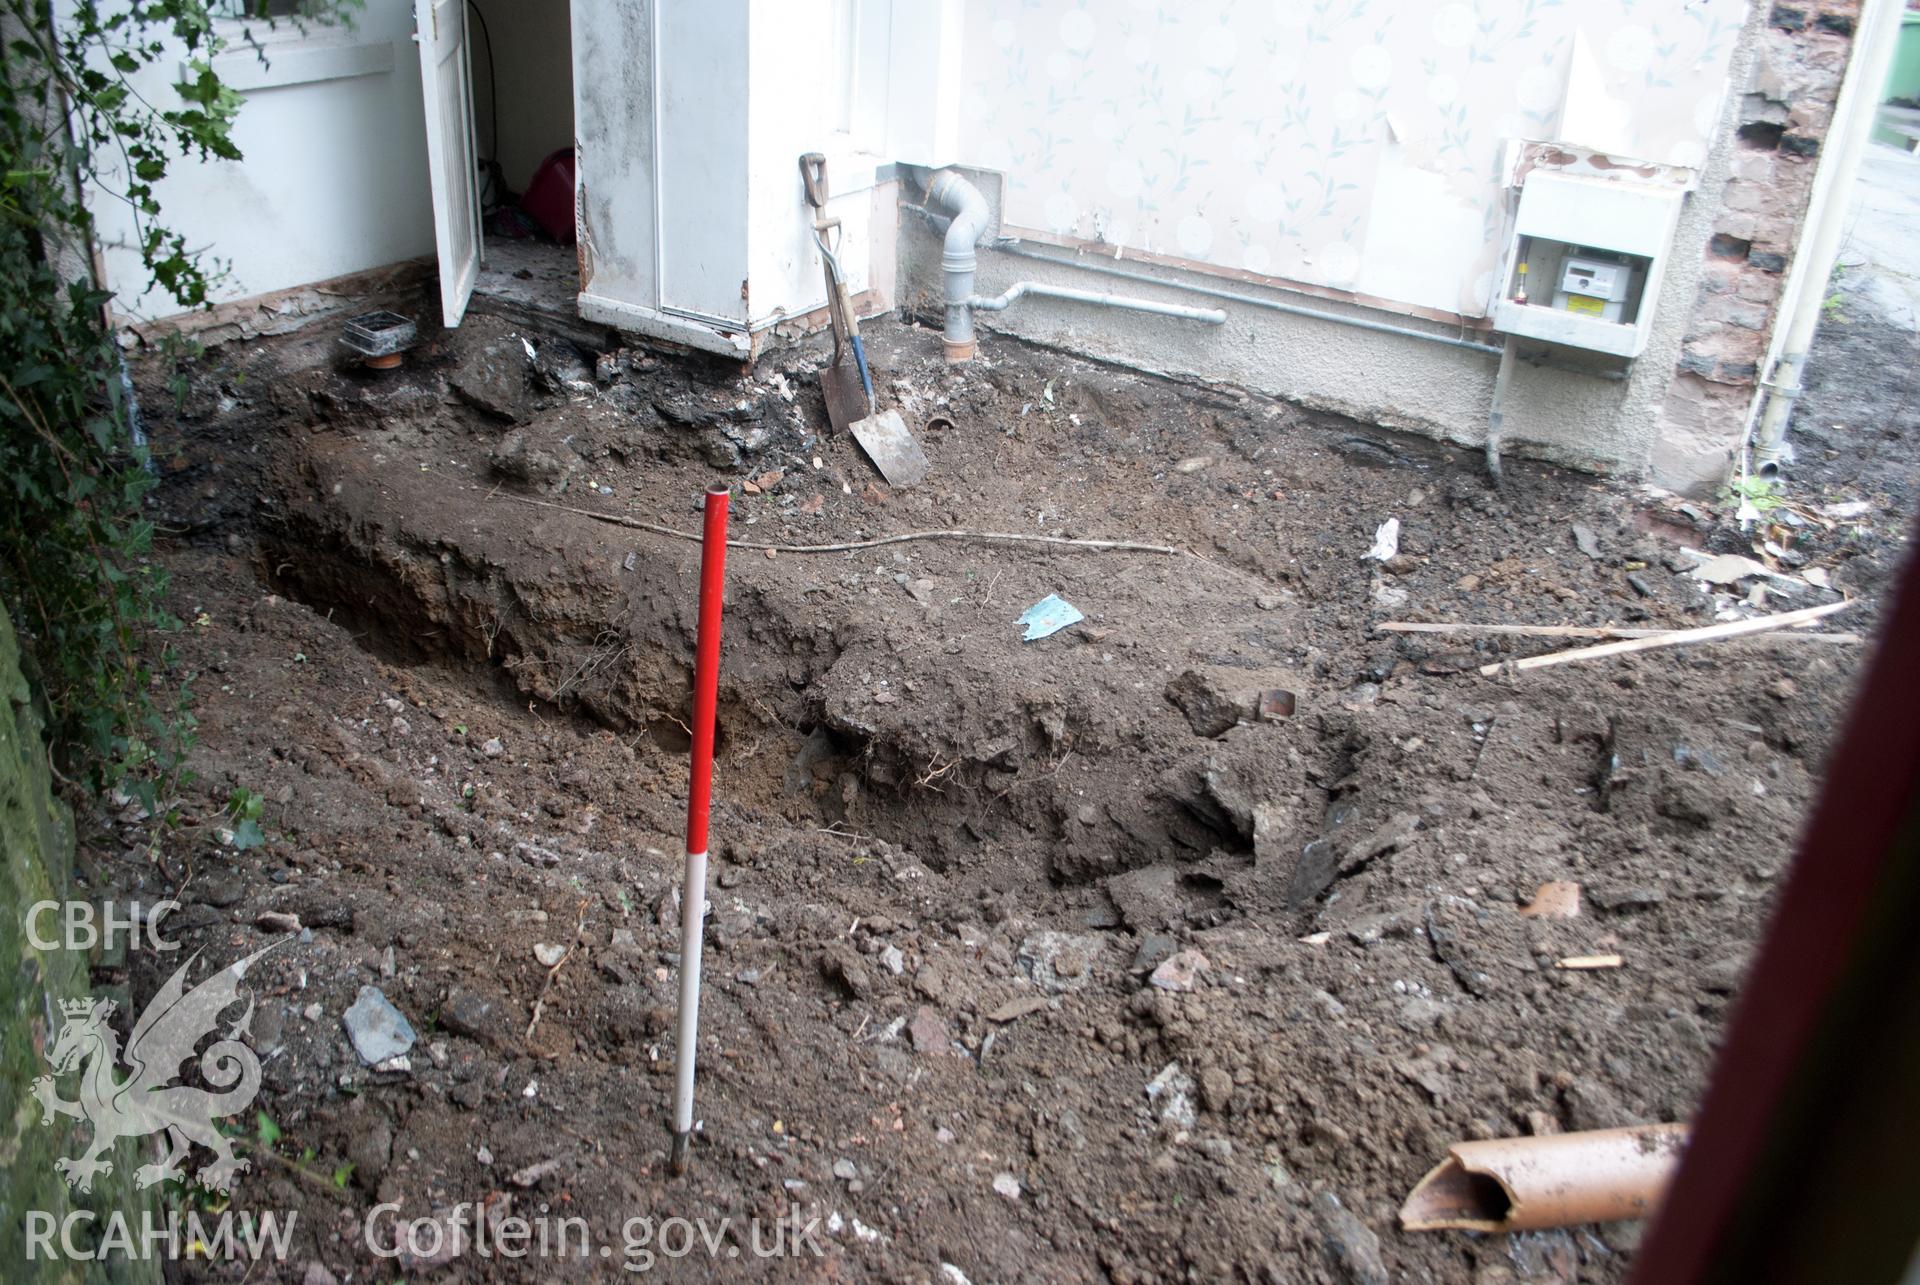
[96,282,1912,1281]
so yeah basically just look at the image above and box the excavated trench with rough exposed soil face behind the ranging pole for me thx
[261,448,1363,910]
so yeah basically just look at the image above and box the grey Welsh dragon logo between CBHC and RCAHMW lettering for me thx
[33,945,273,1193]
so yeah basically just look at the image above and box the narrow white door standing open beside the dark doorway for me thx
[413,0,480,328]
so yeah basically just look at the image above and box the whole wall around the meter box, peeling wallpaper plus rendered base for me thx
[900,0,1766,486]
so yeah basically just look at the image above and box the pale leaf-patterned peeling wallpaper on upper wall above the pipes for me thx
[960,0,1747,317]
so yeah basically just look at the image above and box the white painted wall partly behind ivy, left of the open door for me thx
[92,0,434,317]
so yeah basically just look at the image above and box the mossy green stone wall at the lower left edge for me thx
[0,611,159,1281]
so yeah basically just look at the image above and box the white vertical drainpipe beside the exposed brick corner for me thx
[1741,0,1907,473]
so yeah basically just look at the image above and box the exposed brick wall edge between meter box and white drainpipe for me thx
[1653,0,1860,482]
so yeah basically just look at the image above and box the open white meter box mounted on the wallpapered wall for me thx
[1494,169,1686,357]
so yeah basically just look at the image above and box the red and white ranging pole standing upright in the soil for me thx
[672,486,728,1174]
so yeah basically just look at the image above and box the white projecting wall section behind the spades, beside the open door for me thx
[574,0,933,353]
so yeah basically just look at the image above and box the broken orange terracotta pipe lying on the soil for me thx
[1400,1124,1688,1231]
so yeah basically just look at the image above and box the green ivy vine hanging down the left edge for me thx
[0,0,357,811]
